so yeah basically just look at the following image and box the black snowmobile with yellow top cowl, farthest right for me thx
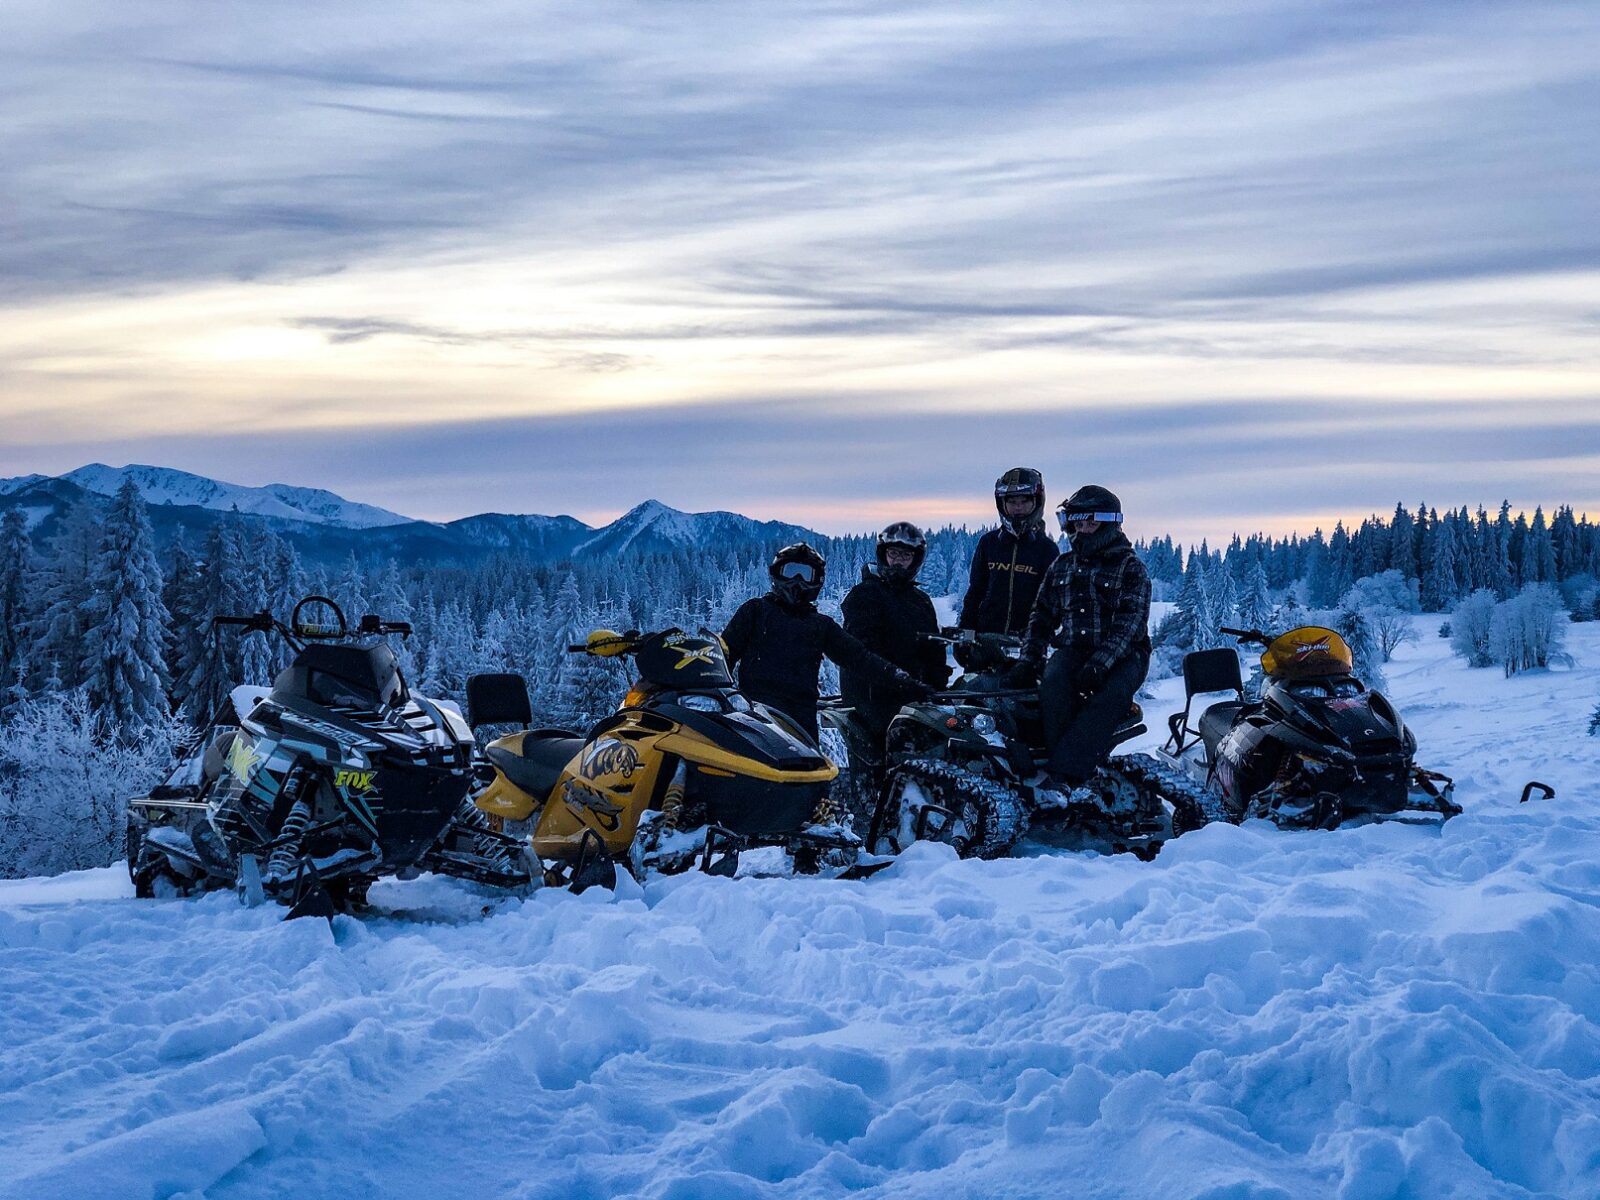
[1162,626,1461,829]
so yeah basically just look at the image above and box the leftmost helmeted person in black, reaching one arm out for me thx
[722,542,930,741]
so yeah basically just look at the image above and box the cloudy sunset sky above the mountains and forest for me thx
[0,0,1600,541]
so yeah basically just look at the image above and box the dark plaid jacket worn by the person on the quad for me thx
[1022,531,1150,670]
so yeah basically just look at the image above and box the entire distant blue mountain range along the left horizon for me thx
[0,462,821,563]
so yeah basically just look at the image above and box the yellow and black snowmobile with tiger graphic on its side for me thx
[467,629,859,891]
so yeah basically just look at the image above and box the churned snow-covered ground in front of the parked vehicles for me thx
[0,618,1600,1200]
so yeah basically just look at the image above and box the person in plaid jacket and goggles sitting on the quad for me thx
[1006,483,1150,792]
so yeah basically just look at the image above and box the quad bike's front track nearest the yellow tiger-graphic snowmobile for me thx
[867,758,1027,859]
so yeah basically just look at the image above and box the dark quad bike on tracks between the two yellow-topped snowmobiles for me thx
[822,629,1221,858]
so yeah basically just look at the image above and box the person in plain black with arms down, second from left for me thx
[838,522,950,750]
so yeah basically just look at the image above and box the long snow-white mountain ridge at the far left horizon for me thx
[50,462,411,530]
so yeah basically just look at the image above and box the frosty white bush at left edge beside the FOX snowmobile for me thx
[0,688,187,878]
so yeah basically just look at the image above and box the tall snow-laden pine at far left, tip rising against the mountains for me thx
[82,478,170,742]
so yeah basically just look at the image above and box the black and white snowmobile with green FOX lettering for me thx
[128,595,528,917]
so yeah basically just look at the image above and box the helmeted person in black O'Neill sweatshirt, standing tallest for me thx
[955,467,1059,634]
